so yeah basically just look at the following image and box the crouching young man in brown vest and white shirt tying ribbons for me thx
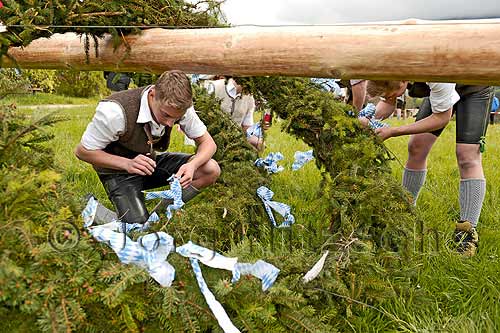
[75,70,220,223]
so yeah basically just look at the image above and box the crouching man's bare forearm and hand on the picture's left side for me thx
[75,144,156,176]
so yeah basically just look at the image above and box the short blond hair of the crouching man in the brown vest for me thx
[155,70,193,111]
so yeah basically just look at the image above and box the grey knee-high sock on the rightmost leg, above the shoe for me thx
[459,178,486,227]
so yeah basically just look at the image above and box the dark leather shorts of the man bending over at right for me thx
[416,85,494,144]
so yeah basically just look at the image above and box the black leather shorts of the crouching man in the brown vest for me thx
[99,153,192,223]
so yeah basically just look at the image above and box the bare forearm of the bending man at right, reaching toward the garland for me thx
[375,108,452,140]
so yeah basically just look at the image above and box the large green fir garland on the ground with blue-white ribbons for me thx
[0,78,424,332]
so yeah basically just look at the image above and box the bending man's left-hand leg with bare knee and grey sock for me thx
[403,133,437,205]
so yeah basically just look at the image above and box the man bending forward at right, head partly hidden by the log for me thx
[362,81,493,256]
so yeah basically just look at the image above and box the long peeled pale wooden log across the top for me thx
[3,20,500,85]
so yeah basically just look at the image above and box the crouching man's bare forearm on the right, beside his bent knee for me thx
[176,132,217,188]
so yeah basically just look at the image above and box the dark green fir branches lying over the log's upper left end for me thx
[0,0,224,65]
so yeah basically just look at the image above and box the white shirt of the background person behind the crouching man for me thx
[205,79,255,126]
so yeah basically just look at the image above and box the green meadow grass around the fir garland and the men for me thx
[6,96,500,332]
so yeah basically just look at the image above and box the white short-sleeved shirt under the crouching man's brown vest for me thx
[80,87,207,150]
